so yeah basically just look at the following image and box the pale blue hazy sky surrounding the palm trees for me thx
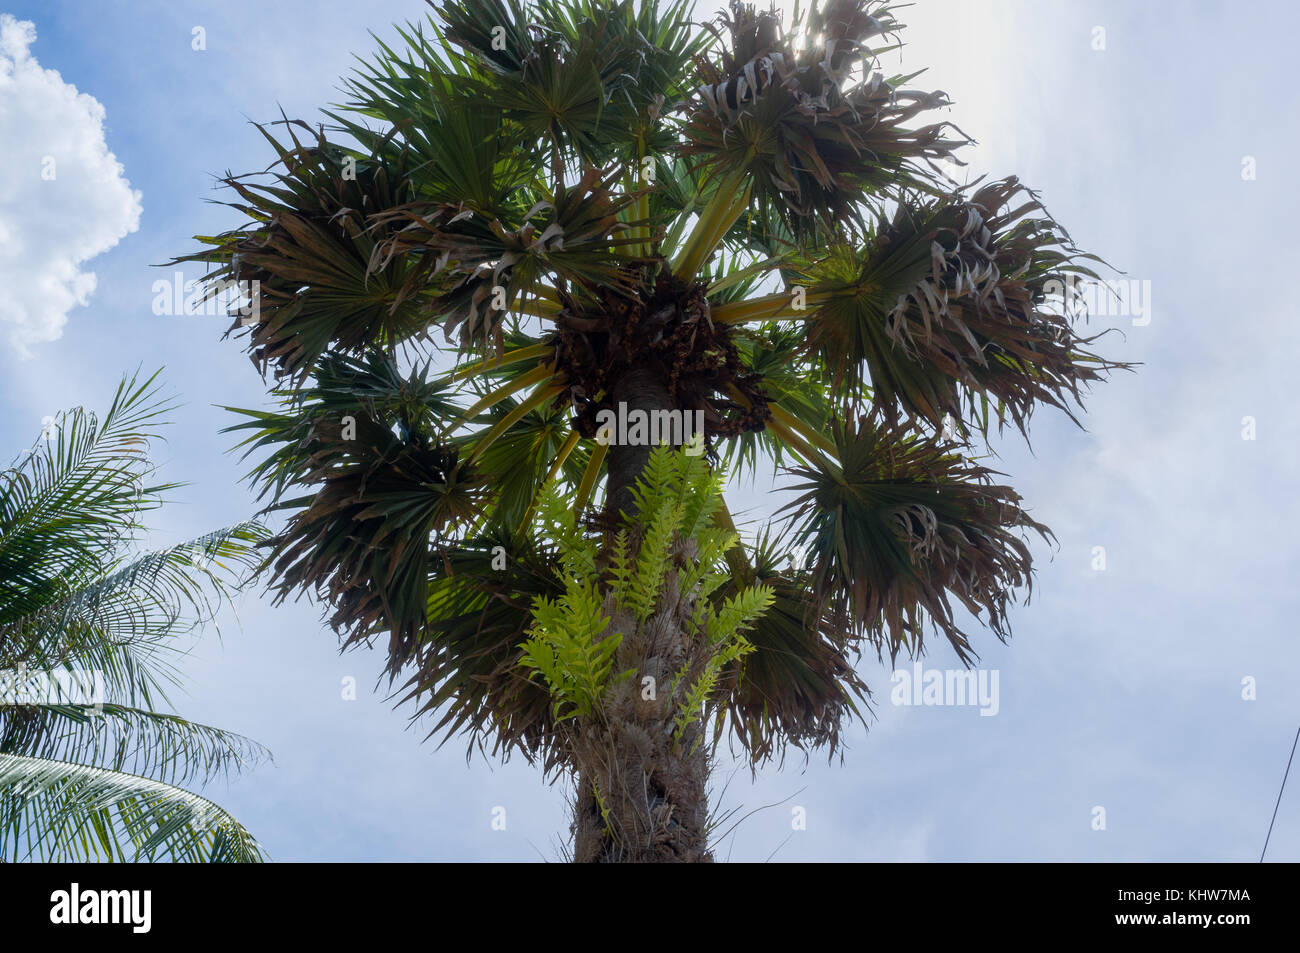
[0,0,1300,861]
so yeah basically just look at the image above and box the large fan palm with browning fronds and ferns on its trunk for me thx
[176,0,1121,861]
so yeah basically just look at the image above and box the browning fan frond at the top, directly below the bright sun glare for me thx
[684,0,966,235]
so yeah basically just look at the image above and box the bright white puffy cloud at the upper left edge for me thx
[0,14,140,356]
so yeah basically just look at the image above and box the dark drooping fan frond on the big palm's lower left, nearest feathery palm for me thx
[228,355,486,672]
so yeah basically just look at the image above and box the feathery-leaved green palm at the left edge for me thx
[0,374,267,861]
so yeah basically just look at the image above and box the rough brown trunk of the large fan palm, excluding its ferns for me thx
[573,371,712,863]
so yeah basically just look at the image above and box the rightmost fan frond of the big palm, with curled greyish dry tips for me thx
[797,178,1126,433]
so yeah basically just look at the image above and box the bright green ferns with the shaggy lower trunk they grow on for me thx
[520,447,774,861]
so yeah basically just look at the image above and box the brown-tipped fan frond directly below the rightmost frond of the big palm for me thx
[787,417,1050,660]
